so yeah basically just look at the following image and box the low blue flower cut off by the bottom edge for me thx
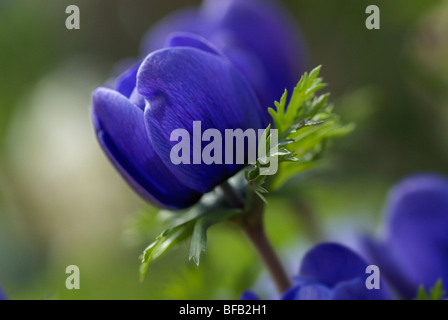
[241,243,390,300]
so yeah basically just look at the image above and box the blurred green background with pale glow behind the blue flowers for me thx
[0,0,448,299]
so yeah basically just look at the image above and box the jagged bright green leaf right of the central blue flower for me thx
[246,66,354,192]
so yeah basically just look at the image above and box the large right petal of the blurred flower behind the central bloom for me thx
[204,0,307,107]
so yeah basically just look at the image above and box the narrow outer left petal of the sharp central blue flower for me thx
[92,88,200,209]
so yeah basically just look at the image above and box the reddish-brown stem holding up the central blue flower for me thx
[221,182,291,294]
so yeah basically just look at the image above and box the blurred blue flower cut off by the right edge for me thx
[363,175,448,299]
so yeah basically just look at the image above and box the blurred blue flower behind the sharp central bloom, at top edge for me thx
[142,0,307,114]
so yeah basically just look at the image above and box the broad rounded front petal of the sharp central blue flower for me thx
[137,39,264,193]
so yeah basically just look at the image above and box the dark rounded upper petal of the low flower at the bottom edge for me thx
[299,243,367,288]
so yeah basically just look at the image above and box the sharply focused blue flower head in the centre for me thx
[92,34,266,209]
